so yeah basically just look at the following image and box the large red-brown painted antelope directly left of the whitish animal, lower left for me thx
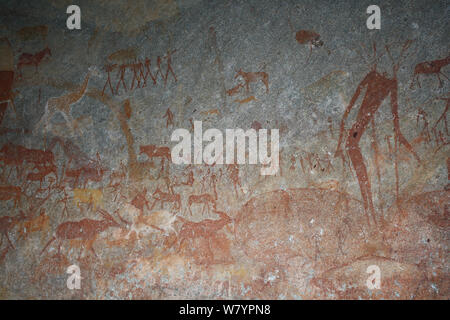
[41,209,123,258]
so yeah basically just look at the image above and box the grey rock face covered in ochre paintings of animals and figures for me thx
[0,1,450,299]
